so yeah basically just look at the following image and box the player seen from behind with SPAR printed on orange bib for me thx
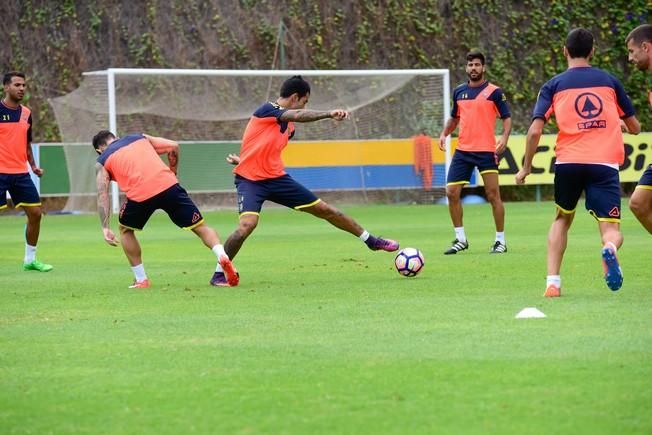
[516,28,641,297]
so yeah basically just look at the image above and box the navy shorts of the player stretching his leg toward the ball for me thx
[235,174,320,215]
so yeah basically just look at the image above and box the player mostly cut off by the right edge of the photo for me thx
[625,24,652,234]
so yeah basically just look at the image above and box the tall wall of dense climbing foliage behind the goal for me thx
[0,0,652,141]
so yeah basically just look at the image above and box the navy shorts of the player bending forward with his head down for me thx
[119,184,204,230]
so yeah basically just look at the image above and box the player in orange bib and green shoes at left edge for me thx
[0,71,52,272]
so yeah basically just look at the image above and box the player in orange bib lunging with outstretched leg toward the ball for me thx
[222,76,399,286]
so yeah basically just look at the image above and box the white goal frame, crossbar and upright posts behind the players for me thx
[83,68,451,213]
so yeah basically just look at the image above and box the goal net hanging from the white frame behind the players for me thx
[50,69,450,211]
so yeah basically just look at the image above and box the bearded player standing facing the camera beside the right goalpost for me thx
[439,52,512,255]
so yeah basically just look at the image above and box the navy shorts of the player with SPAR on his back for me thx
[555,163,620,222]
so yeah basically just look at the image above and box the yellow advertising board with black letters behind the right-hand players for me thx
[498,133,652,186]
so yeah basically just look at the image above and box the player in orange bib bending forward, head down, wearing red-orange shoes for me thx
[93,130,239,288]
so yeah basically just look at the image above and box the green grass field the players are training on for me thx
[0,203,652,434]
